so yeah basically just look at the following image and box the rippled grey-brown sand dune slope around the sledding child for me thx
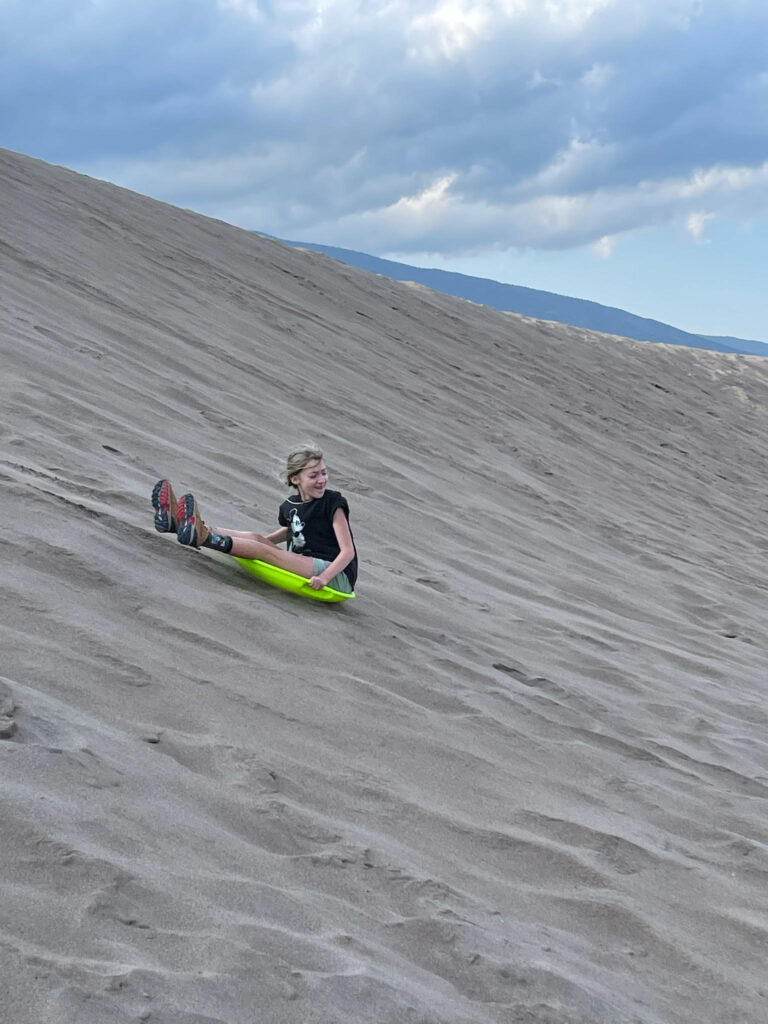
[0,152,768,1024]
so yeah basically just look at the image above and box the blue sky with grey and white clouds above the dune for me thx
[0,0,768,341]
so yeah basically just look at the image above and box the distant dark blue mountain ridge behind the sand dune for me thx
[281,239,768,356]
